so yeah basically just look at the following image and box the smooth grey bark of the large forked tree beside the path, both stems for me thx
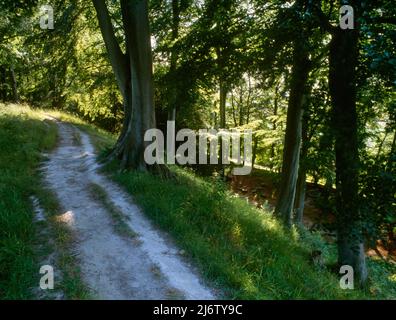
[93,0,155,170]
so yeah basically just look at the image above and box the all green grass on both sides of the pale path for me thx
[0,105,396,299]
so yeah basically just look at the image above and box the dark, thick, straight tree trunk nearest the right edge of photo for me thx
[329,25,367,285]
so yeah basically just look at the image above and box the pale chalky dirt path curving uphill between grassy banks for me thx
[44,122,215,299]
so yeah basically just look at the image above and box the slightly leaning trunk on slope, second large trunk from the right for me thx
[275,39,311,227]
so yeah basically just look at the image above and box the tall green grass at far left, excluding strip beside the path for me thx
[0,104,56,299]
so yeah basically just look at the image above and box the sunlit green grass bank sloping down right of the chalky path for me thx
[59,110,396,299]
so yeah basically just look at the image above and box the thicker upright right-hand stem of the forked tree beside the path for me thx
[121,0,155,170]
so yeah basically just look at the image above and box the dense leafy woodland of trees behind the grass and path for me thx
[0,0,396,286]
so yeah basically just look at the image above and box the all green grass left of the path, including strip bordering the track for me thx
[0,104,88,299]
